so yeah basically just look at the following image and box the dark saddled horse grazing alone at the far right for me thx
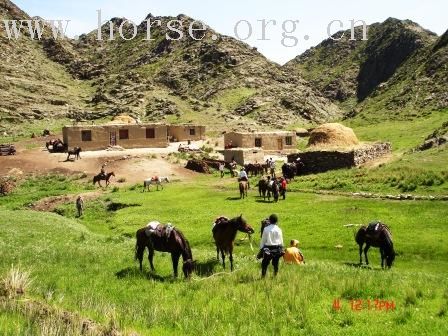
[355,222,395,268]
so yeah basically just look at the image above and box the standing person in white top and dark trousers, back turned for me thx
[259,214,283,278]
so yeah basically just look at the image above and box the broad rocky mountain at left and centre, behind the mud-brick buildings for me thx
[0,0,342,133]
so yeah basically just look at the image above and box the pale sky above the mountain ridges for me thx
[13,0,448,64]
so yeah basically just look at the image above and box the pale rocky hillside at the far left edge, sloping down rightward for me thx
[0,0,91,128]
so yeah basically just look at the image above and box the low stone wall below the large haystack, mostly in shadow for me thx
[288,143,391,174]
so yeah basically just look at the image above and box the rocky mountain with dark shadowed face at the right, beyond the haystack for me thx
[285,18,448,119]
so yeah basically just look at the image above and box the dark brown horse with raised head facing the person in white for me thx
[212,215,254,271]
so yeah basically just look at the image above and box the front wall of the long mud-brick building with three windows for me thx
[62,124,168,150]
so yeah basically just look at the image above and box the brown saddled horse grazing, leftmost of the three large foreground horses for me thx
[135,225,194,278]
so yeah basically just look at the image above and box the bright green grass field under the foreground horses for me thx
[0,176,448,335]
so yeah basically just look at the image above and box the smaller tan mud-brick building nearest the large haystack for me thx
[224,131,297,151]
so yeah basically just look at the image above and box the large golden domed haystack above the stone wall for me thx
[308,123,359,148]
